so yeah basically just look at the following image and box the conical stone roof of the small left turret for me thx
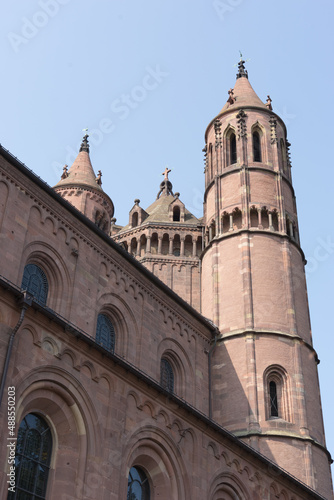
[54,134,103,191]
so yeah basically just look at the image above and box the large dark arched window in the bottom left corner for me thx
[7,413,52,500]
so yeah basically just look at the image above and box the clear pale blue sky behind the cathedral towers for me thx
[0,0,334,480]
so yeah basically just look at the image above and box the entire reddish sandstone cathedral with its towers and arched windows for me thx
[0,59,334,500]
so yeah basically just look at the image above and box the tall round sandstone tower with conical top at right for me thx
[202,60,332,498]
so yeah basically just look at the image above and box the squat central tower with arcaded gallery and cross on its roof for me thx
[111,168,202,310]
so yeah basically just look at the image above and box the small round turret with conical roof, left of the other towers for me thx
[54,134,114,234]
